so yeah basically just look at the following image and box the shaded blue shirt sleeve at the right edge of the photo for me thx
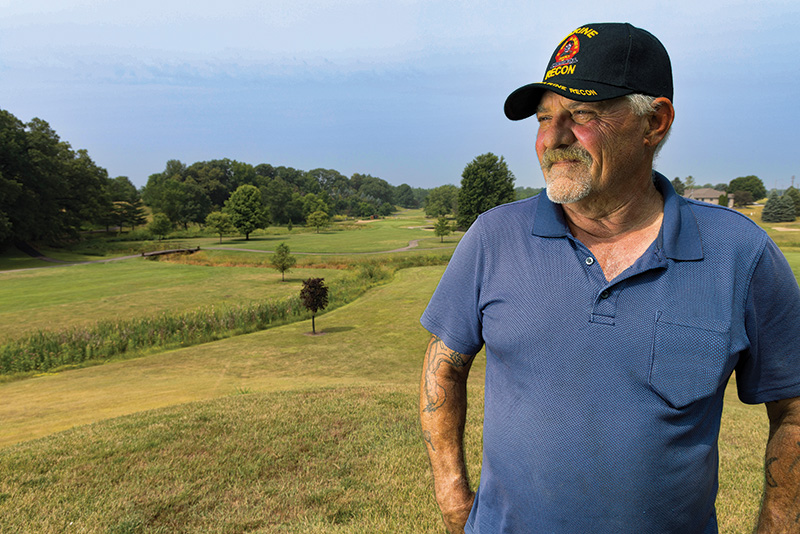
[736,240,800,404]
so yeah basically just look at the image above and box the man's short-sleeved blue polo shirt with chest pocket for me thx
[422,173,800,534]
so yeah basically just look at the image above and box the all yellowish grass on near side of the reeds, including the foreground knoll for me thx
[0,267,767,533]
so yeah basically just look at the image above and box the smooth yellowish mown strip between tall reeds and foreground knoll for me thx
[0,266,462,446]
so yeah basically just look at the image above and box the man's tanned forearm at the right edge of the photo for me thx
[755,397,800,534]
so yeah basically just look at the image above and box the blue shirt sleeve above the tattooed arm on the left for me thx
[420,217,485,355]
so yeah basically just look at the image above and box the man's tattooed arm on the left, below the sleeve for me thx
[420,336,474,533]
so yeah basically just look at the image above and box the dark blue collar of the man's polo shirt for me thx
[532,171,703,261]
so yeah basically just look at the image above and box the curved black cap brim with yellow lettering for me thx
[504,80,633,121]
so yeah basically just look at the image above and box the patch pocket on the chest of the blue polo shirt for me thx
[649,312,731,409]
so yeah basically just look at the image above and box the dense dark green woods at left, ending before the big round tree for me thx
[0,110,427,246]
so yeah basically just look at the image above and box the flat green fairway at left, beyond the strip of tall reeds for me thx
[0,255,343,340]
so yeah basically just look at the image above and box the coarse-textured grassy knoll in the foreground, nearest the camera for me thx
[0,386,480,534]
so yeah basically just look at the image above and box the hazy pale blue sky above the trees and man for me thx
[0,0,800,188]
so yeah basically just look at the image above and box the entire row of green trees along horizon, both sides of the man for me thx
[0,105,800,247]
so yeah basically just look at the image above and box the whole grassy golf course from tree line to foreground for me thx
[0,210,800,534]
